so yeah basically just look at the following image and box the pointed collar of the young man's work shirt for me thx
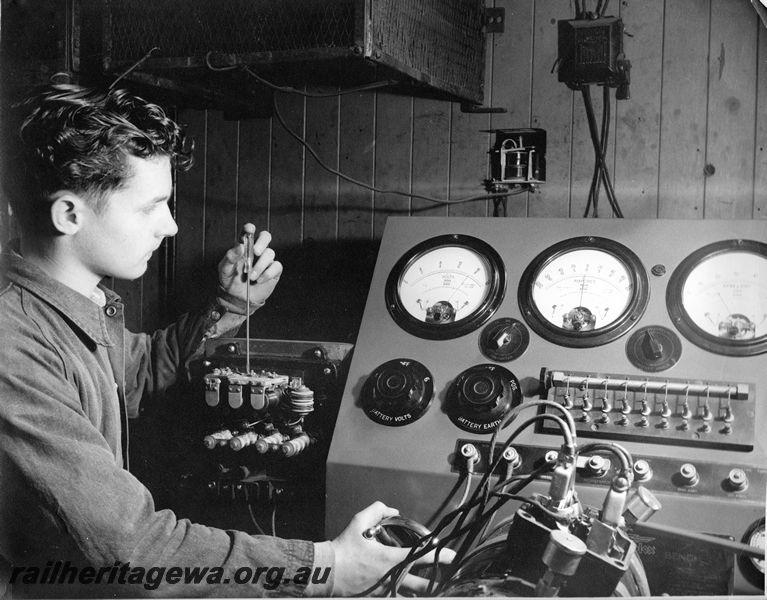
[0,247,122,346]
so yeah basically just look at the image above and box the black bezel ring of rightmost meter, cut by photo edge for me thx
[666,239,767,356]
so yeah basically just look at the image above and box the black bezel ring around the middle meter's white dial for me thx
[517,236,650,348]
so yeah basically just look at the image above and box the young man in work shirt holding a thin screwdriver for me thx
[0,85,447,597]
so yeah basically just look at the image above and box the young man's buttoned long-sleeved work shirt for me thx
[0,251,333,597]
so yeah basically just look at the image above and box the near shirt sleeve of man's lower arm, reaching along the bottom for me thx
[0,316,329,597]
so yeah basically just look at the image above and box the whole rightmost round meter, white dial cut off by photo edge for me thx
[666,240,767,356]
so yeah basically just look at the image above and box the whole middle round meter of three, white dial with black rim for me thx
[519,237,648,348]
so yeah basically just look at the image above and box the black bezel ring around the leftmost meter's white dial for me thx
[384,233,506,340]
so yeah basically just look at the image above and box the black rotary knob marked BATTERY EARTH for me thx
[446,364,522,433]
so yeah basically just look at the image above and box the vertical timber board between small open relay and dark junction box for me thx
[532,0,573,217]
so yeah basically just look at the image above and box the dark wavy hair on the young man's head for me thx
[3,84,192,231]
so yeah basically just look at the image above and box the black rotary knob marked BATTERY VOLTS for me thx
[361,358,434,427]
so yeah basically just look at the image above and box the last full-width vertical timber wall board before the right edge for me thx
[705,0,761,219]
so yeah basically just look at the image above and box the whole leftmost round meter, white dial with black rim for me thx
[386,235,506,339]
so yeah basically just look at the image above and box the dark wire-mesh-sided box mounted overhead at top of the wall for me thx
[103,0,485,102]
